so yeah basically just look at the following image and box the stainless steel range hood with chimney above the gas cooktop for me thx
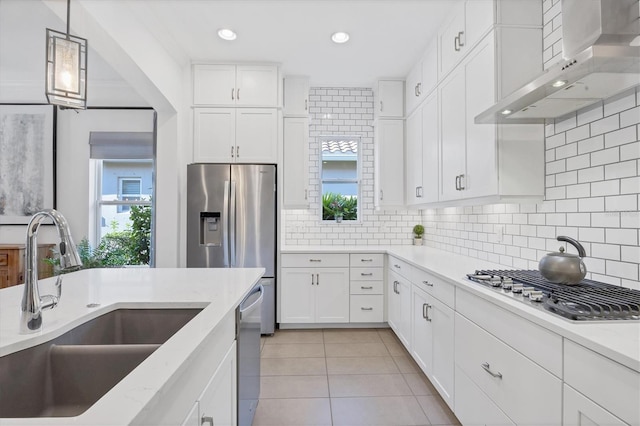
[475,0,640,124]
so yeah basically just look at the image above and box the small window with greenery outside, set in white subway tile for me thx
[320,136,360,222]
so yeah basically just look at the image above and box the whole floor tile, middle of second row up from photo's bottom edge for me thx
[329,374,412,398]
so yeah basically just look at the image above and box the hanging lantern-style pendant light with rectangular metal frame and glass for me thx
[46,0,88,109]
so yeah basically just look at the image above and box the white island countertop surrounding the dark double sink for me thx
[0,268,264,426]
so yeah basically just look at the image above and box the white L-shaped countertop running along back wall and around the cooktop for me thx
[281,245,640,372]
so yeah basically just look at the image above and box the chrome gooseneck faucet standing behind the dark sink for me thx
[20,209,82,333]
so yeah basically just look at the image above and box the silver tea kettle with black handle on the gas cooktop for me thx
[538,236,587,284]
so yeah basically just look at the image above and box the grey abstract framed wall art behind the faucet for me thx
[0,104,56,225]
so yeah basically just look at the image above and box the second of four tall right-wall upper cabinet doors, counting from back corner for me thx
[418,90,440,203]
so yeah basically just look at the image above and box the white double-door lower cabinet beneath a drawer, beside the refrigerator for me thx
[280,268,349,324]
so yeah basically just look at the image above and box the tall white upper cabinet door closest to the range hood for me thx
[462,33,498,198]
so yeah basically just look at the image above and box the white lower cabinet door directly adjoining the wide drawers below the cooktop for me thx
[430,297,455,407]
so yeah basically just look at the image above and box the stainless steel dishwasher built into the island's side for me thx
[237,283,264,426]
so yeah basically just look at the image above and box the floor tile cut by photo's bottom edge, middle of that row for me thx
[331,396,429,426]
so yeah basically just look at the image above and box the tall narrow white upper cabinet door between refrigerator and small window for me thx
[283,117,309,209]
